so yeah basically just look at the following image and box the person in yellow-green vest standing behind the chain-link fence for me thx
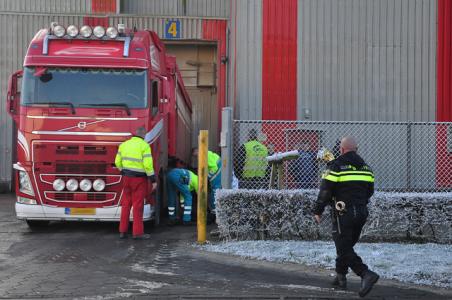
[234,129,268,189]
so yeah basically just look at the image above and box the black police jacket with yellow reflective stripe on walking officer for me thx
[314,151,374,215]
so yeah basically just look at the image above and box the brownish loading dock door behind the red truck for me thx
[165,42,219,157]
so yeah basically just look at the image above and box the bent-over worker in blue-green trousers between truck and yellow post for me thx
[166,168,198,225]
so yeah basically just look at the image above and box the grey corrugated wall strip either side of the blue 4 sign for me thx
[109,15,202,39]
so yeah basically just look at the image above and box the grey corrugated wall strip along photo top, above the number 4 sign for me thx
[121,0,231,18]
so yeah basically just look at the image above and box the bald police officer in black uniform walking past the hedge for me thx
[314,136,379,297]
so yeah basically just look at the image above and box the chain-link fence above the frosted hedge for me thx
[232,120,452,192]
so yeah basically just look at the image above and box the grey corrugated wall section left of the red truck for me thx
[0,13,82,189]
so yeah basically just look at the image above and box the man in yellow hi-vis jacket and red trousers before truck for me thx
[115,127,156,239]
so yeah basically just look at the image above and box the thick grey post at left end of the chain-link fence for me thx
[220,107,233,189]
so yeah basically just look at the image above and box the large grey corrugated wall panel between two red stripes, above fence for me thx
[297,0,437,121]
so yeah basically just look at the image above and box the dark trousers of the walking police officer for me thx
[333,206,369,276]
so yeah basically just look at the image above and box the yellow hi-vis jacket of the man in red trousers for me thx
[115,136,155,181]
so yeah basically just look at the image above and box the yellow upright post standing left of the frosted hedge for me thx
[197,130,209,244]
